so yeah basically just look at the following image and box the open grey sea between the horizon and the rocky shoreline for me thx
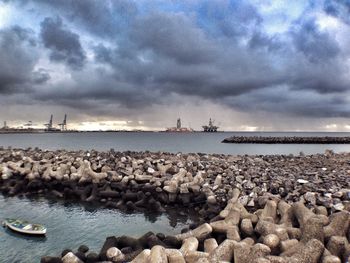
[0,132,350,154]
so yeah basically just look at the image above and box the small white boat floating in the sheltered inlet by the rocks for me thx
[3,218,46,235]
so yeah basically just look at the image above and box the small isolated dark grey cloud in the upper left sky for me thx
[40,17,86,69]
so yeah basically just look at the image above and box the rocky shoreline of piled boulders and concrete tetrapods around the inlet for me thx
[0,148,350,263]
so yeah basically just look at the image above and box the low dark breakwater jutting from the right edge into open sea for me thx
[222,136,350,144]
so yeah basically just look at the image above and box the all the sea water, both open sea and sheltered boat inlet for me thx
[0,132,350,263]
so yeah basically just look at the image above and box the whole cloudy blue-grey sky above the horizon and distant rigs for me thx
[0,0,350,131]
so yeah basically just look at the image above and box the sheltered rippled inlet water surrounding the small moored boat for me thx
[0,195,187,263]
